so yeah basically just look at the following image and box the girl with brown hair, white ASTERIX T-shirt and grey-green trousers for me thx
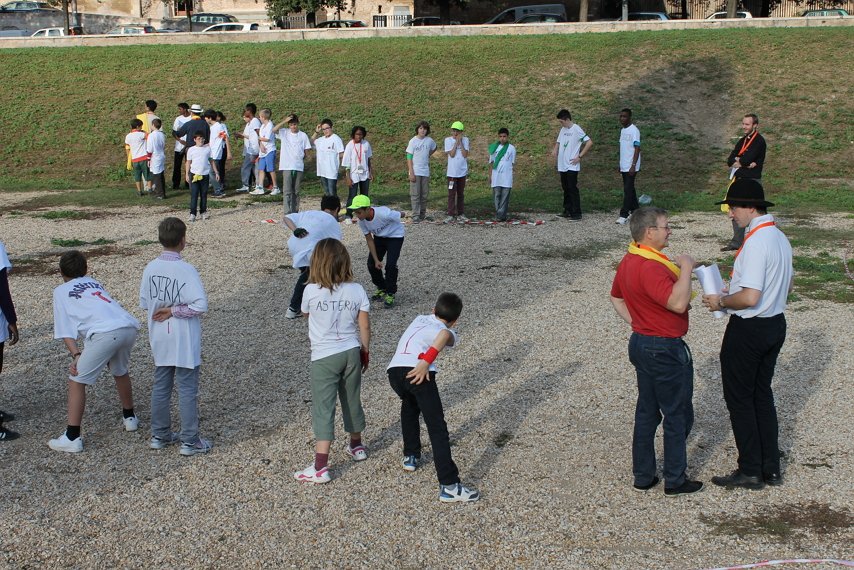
[294,238,371,483]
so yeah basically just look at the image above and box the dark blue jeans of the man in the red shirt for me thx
[629,333,694,489]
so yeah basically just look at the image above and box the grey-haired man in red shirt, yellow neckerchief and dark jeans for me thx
[611,208,703,497]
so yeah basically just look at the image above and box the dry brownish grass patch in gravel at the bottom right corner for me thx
[700,502,854,541]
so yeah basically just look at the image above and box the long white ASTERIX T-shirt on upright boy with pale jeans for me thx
[139,259,208,368]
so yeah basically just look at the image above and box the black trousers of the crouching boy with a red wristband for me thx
[388,367,460,485]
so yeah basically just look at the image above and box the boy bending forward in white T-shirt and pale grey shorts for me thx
[48,250,140,453]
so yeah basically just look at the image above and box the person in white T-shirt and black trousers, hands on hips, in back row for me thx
[552,109,593,222]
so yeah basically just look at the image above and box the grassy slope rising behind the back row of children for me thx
[0,28,854,211]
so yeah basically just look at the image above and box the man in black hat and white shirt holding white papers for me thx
[703,178,794,489]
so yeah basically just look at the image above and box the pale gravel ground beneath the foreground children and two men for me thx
[0,194,854,569]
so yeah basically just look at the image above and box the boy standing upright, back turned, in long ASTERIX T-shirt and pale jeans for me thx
[139,218,212,456]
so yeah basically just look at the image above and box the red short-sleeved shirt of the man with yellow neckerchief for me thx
[611,253,688,338]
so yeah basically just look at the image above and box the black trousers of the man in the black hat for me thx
[721,313,786,477]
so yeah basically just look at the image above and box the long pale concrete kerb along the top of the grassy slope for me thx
[0,17,854,49]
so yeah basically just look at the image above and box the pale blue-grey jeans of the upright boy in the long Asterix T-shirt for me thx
[151,366,199,445]
